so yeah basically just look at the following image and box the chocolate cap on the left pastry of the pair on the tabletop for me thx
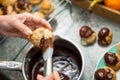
[80,26,94,38]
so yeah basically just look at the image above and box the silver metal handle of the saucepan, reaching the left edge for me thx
[0,61,22,70]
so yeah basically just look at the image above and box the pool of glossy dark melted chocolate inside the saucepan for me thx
[24,36,83,80]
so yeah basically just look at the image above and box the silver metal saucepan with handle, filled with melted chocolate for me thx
[0,35,84,80]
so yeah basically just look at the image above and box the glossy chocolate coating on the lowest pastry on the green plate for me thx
[94,68,113,80]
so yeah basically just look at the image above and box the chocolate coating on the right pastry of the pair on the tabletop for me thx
[98,27,110,46]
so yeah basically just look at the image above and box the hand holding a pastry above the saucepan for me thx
[0,13,52,39]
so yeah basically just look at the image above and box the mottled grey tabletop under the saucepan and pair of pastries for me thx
[0,0,120,80]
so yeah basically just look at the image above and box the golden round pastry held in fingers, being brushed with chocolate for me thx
[30,27,54,47]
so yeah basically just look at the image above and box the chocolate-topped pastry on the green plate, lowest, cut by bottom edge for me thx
[94,66,116,80]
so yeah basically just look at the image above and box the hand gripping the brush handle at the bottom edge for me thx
[37,71,61,80]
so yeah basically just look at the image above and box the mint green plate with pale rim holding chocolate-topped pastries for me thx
[92,43,120,80]
